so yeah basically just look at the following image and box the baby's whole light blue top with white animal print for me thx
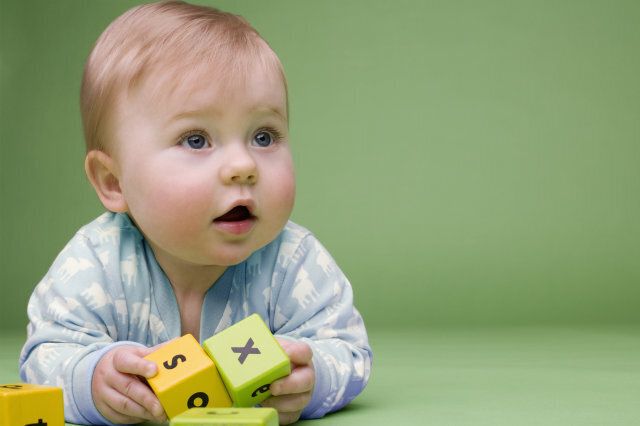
[20,212,372,424]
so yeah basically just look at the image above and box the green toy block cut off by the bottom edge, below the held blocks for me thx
[170,408,278,426]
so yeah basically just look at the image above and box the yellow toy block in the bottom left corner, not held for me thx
[0,383,64,426]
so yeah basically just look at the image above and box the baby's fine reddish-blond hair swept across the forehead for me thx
[80,1,288,151]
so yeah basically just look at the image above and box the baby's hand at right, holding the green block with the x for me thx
[261,339,316,425]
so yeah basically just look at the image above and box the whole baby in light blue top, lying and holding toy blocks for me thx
[20,2,371,424]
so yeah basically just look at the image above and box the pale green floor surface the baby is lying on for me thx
[0,327,640,426]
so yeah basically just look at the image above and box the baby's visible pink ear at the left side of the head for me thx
[84,150,128,213]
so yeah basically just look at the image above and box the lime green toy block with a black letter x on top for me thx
[203,314,291,407]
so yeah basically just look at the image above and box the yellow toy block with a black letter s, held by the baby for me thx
[145,334,231,418]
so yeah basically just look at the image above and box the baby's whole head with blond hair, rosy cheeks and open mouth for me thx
[81,2,295,267]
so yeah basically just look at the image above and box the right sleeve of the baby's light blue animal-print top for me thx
[274,231,372,418]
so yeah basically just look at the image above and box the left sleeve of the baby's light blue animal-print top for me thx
[19,234,141,424]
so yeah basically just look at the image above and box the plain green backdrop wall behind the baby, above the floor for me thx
[0,0,640,331]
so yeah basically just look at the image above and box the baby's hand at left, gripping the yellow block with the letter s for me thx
[91,346,167,424]
